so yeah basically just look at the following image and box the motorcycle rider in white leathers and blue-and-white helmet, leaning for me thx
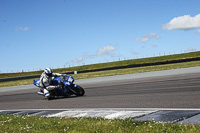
[40,68,66,97]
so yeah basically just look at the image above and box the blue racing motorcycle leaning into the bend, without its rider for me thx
[33,75,85,100]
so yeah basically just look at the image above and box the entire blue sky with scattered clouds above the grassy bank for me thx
[0,0,200,73]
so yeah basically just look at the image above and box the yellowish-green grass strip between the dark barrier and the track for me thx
[0,61,200,87]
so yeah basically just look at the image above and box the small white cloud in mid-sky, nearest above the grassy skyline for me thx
[96,45,115,56]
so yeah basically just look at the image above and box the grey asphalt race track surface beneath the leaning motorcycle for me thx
[0,68,200,110]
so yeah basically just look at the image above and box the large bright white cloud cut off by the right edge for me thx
[162,14,200,30]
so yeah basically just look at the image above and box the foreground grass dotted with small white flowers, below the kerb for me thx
[0,115,200,133]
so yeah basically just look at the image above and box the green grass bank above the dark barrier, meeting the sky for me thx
[0,51,200,78]
